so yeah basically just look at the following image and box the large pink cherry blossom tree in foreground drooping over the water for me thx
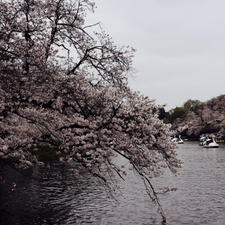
[0,0,180,221]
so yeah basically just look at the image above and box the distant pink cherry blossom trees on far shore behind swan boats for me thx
[172,95,225,139]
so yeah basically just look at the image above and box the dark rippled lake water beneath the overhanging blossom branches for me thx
[0,142,225,225]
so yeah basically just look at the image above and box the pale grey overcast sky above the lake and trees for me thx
[87,0,225,109]
